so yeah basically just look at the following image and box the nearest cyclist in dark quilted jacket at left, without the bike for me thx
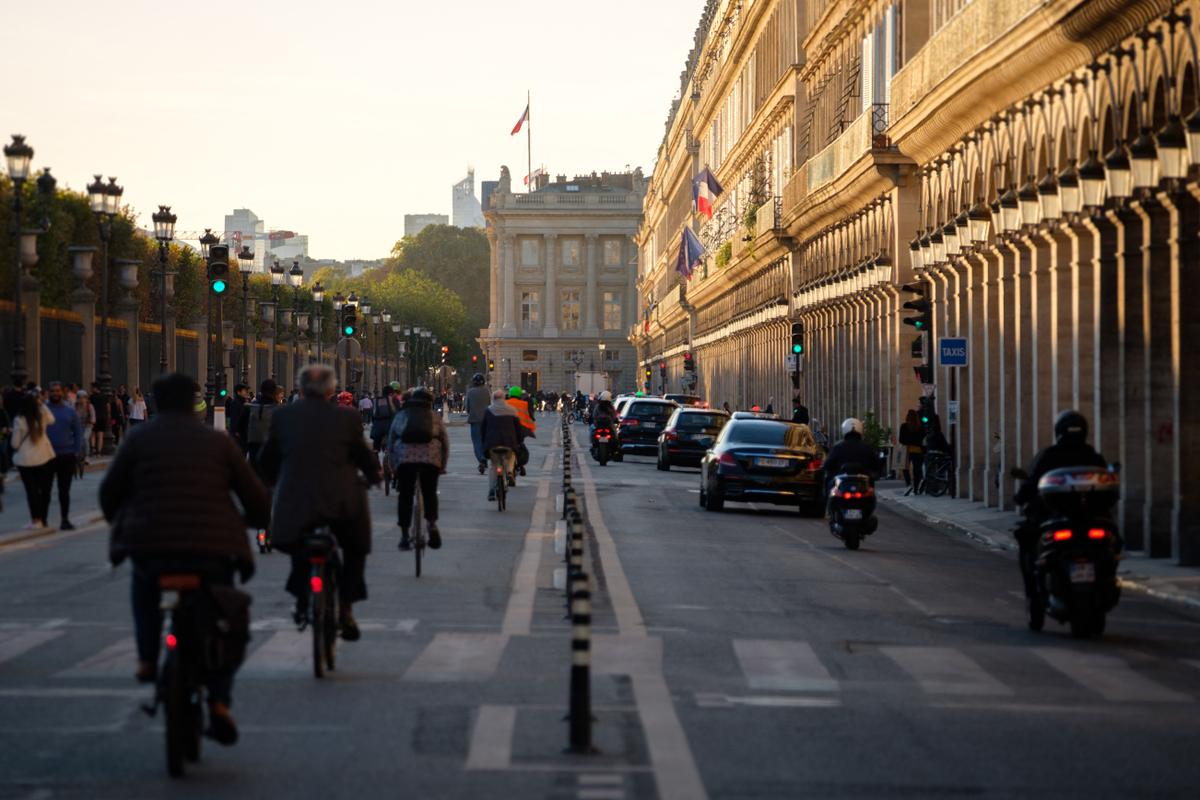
[100,373,270,745]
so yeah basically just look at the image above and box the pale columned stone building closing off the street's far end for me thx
[479,167,646,392]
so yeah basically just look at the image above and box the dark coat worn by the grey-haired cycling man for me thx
[259,397,379,553]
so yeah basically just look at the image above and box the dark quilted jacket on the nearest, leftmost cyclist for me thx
[100,413,270,577]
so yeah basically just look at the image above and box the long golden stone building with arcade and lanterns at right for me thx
[630,0,1200,564]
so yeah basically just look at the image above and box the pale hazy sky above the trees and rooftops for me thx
[0,0,703,259]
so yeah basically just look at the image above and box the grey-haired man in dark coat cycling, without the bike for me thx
[259,365,380,642]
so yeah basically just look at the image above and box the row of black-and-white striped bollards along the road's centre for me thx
[562,415,595,753]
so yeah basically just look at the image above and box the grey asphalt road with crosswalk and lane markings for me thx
[0,417,1200,800]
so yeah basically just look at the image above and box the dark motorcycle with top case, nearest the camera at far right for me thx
[1010,465,1123,638]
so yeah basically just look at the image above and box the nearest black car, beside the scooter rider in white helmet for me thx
[700,414,824,516]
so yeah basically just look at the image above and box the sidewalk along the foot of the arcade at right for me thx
[876,481,1200,609]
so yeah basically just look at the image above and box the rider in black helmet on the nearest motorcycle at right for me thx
[1014,409,1109,599]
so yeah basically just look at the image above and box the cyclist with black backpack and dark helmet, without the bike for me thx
[388,386,450,551]
